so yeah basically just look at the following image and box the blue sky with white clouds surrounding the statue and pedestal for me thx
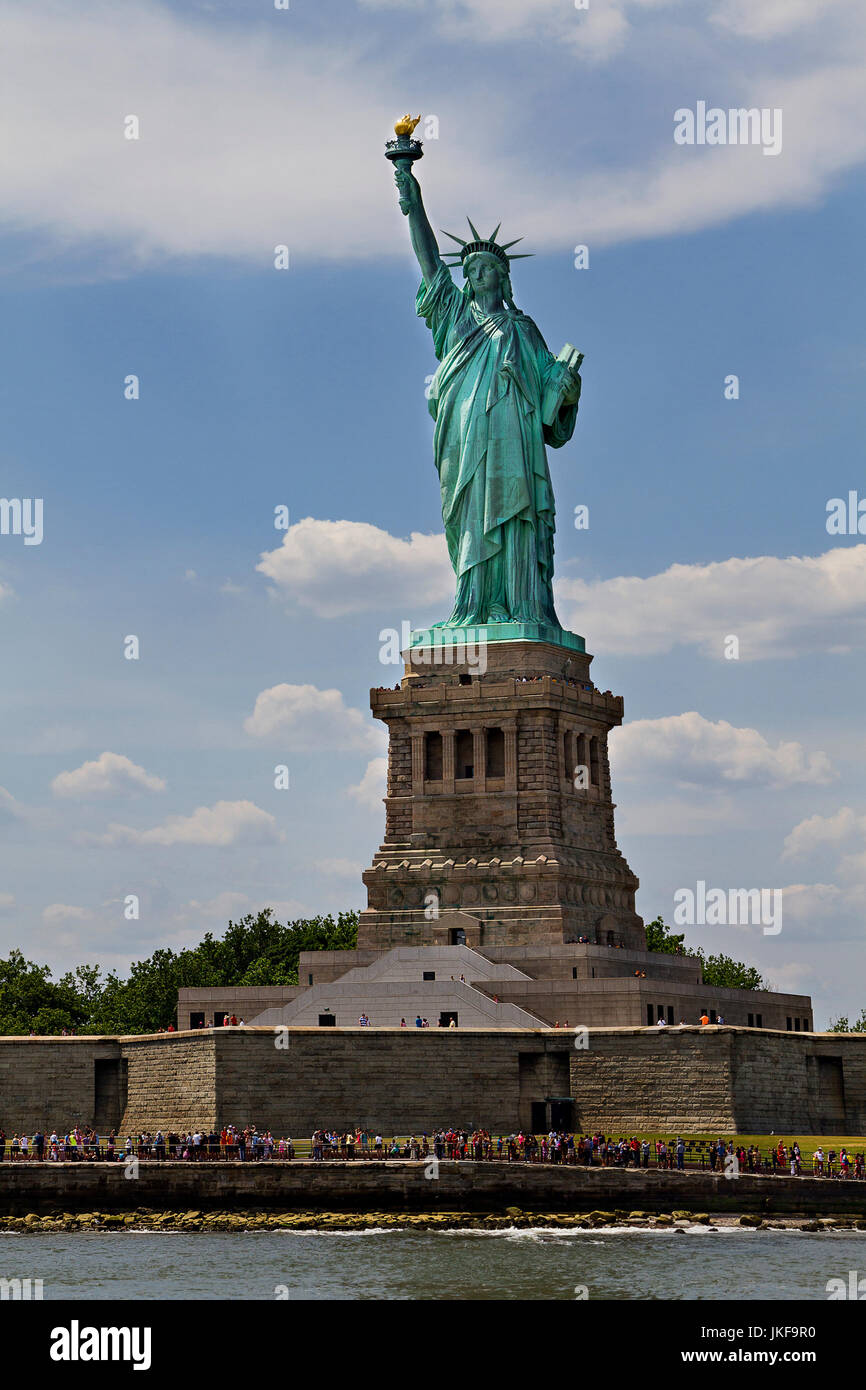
[0,0,866,1022]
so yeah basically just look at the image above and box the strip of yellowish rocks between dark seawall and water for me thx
[0,1207,866,1236]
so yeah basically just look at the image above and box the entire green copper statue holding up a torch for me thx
[388,118,584,651]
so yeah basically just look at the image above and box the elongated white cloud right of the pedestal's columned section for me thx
[610,710,835,787]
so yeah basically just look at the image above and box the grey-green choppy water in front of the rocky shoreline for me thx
[0,1226,866,1301]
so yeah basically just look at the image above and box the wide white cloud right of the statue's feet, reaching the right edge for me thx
[556,545,866,662]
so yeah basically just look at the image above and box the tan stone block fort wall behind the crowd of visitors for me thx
[0,1026,866,1138]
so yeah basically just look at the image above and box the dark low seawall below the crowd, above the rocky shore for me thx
[0,1161,866,1218]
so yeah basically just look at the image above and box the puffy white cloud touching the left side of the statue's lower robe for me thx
[256,517,455,617]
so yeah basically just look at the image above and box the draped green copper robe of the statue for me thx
[416,264,577,627]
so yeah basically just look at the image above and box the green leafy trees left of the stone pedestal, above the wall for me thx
[0,908,357,1036]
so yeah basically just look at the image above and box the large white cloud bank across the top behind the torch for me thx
[0,0,866,274]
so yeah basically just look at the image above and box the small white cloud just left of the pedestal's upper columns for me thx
[243,684,385,752]
